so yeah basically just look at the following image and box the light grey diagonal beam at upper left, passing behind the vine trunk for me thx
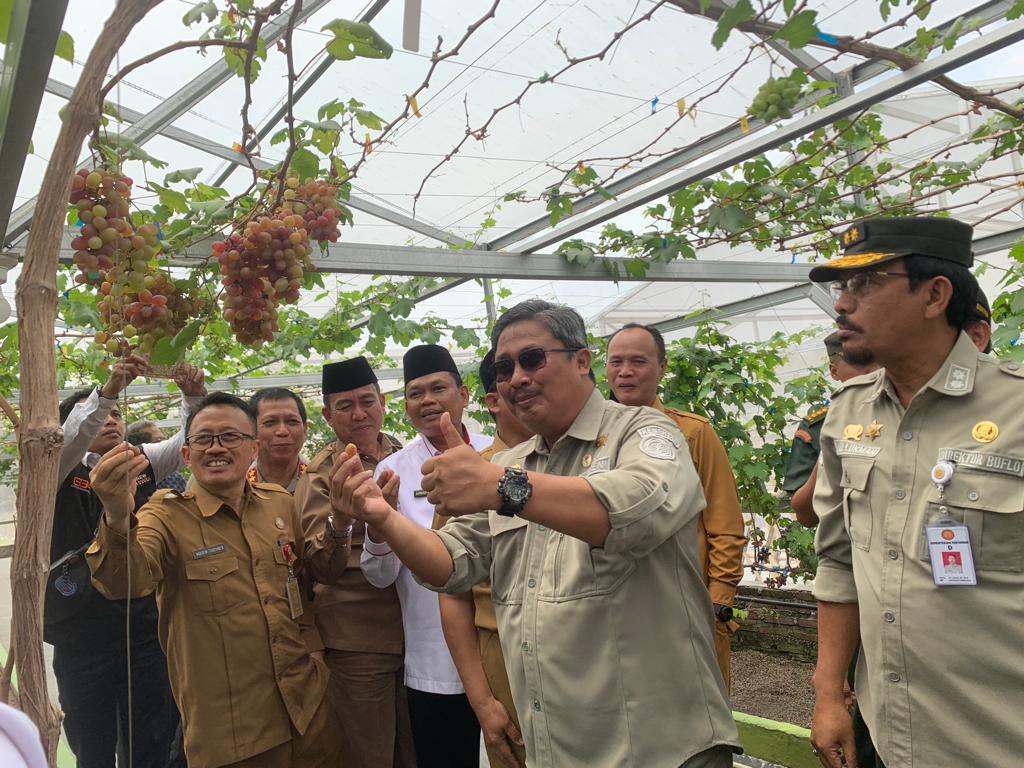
[7,0,329,242]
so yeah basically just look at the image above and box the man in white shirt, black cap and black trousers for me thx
[361,344,490,768]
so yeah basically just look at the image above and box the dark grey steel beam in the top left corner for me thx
[0,0,68,241]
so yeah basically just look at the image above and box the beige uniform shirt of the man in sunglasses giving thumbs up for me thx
[428,389,738,768]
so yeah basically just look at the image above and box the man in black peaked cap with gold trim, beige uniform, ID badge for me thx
[810,217,1024,768]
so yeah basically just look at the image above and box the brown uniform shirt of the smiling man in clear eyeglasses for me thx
[86,483,346,768]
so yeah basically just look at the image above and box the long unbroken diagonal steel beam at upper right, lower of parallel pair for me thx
[512,19,1024,253]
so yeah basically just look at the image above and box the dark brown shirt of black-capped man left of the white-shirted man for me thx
[295,434,404,653]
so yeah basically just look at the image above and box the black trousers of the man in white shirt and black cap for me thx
[407,688,480,768]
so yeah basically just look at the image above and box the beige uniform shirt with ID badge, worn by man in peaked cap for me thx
[814,334,1024,768]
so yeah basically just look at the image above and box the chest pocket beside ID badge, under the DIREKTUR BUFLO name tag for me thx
[921,479,1024,573]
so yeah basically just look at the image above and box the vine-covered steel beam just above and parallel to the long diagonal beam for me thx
[486,0,1013,250]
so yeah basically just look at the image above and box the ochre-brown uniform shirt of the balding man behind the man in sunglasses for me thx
[654,398,746,605]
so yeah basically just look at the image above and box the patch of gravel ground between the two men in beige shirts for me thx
[732,650,814,728]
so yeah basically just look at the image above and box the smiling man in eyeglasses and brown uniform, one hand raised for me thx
[86,392,348,768]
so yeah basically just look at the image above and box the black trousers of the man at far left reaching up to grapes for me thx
[53,636,179,768]
